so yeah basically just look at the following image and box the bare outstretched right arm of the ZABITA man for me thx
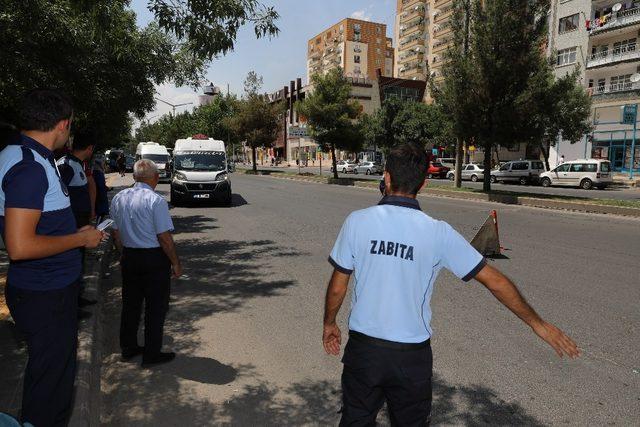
[475,265,580,358]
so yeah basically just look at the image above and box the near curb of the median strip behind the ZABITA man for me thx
[251,173,640,218]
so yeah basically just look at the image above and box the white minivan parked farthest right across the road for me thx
[540,159,613,190]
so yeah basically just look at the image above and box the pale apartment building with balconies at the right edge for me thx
[549,0,640,171]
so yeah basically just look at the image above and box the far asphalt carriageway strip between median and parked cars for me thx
[244,164,640,200]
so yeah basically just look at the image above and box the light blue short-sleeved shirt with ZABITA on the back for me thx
[329,196,485,343]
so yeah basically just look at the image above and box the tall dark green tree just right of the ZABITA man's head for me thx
[436,0,549,191]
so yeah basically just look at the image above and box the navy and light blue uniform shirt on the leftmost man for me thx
[0,135,81,291]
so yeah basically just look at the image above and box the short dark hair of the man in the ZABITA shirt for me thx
[384,144,429,194]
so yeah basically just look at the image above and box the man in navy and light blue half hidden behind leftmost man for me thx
[57,131,97,310]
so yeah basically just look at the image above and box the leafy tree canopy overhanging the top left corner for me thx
[0,0,278,147]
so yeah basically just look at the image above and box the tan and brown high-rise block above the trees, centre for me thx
[307,18,394,81]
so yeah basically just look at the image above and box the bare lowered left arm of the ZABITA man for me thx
[322,270,351,356]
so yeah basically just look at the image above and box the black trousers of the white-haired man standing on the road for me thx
[120,248,171,357]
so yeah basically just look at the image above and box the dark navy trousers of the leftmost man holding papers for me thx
[5,283,79,427]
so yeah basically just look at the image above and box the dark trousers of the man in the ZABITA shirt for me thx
[340,331,432,426]
